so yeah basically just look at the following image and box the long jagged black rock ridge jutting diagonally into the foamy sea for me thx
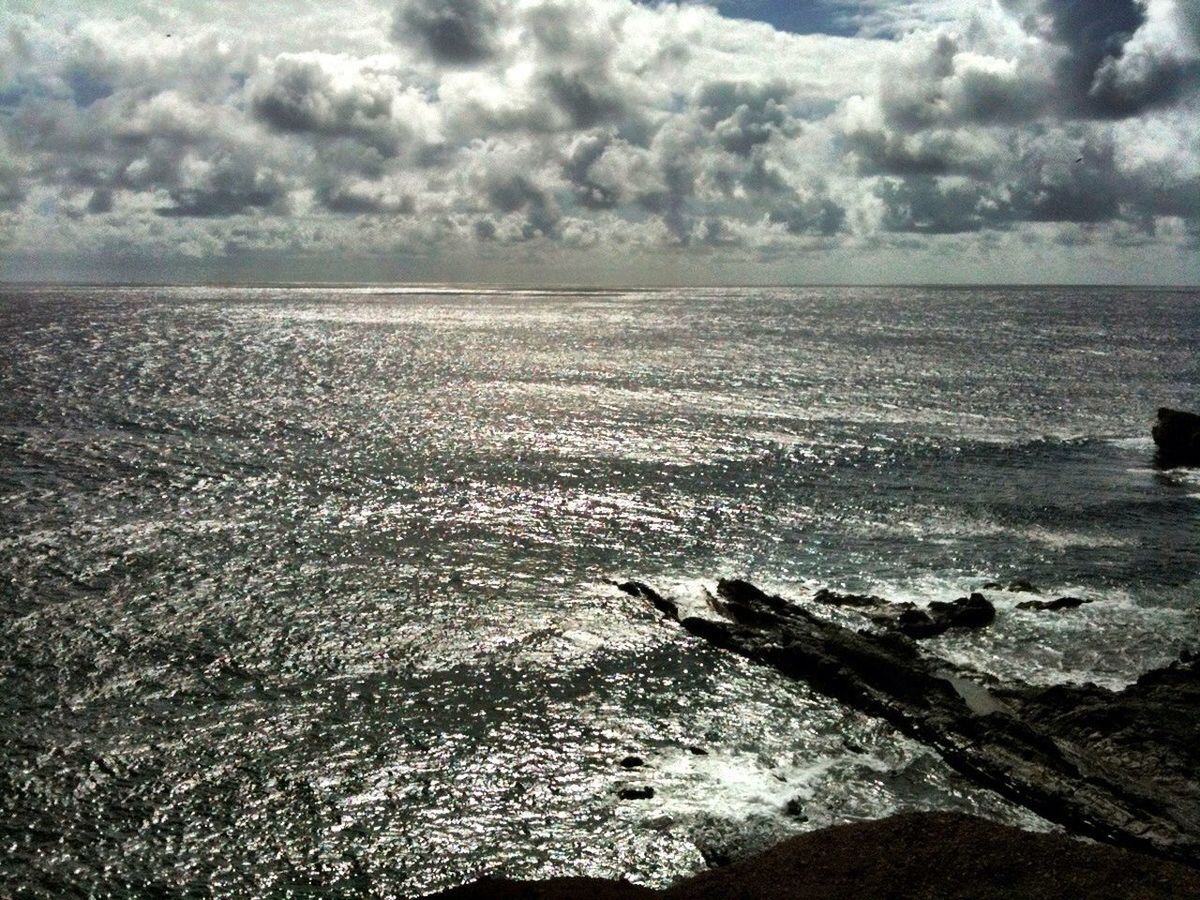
[637,581,1200,864]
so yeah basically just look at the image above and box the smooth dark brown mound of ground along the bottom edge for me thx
[424,812,1200,900]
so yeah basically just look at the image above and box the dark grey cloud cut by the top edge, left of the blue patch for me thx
[392,0,500,65]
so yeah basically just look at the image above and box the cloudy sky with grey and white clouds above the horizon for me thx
[0,0,1200,284]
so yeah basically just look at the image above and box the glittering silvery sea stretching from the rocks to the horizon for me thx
[0,287,1200,896]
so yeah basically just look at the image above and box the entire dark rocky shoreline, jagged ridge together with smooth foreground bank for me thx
[437,578,1200,900]
